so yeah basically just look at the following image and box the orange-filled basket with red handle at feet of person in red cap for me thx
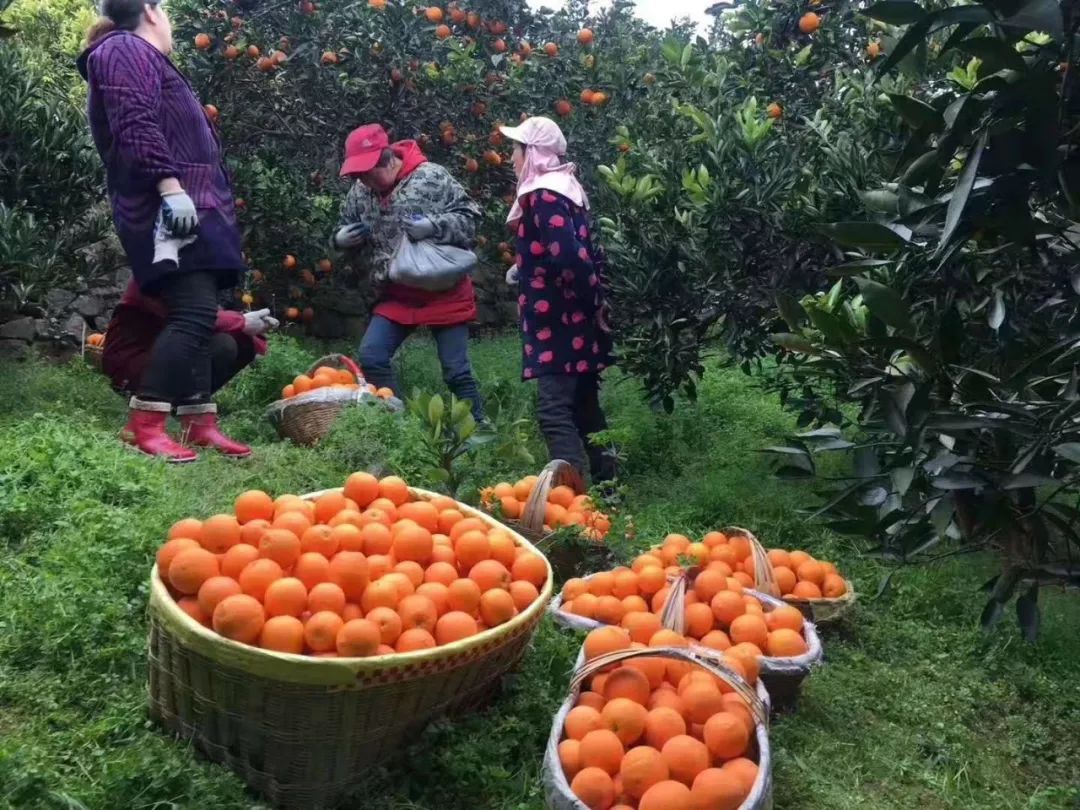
[267,354,402,446]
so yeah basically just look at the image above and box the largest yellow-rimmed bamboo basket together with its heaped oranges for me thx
[149,473,552,810]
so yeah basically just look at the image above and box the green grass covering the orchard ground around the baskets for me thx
[0,339,1080,810]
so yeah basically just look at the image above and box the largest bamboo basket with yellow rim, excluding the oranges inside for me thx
[149,489,552,810]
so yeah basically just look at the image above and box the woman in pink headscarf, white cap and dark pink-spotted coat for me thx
[501,118,615,484]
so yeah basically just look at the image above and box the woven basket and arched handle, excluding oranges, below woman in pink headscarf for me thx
[492,459,611,582]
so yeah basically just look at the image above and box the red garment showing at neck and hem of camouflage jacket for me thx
[375,140,476,326]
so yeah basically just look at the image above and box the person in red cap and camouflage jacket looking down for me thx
[334,124,485,422]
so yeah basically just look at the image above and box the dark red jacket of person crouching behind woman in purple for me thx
[102,279,267,391]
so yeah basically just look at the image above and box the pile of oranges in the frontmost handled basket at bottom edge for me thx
[558,627,758,810]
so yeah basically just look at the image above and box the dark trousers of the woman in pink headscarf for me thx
[537,374,616,484]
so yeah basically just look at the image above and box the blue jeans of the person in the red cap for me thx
[356,315,484,421]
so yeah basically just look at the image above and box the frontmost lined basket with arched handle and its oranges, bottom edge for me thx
[544,643,772,810]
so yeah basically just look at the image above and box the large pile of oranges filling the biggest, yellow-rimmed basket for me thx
[158,473,549,658]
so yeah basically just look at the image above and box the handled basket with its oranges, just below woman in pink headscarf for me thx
[481,459,612,582]
